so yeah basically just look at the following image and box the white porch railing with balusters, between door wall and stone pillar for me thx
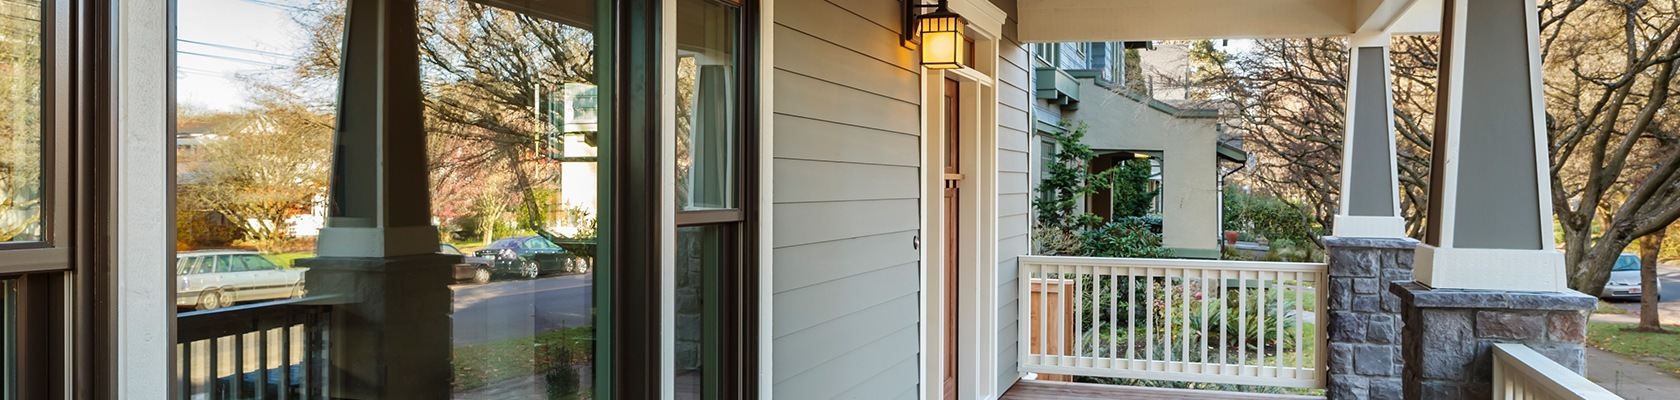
[1018,255,1329,388]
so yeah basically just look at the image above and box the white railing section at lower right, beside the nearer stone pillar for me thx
[1494,343,1621,400]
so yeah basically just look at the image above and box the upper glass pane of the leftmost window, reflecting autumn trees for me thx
[0,0,44,242]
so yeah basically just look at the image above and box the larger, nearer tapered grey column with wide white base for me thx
[1416,0,1567,291]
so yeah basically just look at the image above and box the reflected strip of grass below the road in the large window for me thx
[454,326,595,392]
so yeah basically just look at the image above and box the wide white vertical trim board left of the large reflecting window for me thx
[117,2,175,398]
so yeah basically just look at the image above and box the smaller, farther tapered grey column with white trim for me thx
[1334,32,1406,239]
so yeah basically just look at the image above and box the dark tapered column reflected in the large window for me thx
[316,0,437,257]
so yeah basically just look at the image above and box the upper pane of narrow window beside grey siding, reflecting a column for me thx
[675,0,739,210]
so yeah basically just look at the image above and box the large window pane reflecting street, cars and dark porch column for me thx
[170,0,611,400]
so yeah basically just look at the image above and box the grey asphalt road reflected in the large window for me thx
[450,272,595,346]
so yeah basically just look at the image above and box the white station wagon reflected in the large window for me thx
[175,250,304,309]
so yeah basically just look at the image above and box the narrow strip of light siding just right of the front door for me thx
[993,10,1037,393]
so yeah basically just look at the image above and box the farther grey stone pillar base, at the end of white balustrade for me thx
[1320,237,1418,398]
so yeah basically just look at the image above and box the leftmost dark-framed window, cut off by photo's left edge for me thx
[0,0,74,400]
